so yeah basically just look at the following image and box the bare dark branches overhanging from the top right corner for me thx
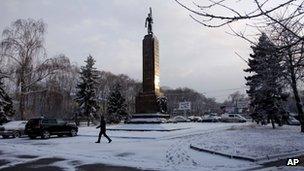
[175,0,304,40]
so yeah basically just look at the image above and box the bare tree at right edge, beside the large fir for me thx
[269,18,304,132]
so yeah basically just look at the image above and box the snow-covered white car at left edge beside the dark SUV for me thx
[0,121,27,138]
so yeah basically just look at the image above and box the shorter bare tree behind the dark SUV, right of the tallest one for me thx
[26,54,79,119]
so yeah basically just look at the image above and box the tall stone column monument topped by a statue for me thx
[132,8,168,122]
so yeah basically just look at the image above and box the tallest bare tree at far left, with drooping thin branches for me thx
[0,19,62,119]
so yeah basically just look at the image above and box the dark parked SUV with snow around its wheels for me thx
[25,118,78,139]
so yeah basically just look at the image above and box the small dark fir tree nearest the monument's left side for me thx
[107,84,127,123]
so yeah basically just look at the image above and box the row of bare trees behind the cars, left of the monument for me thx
[0,19,140,123]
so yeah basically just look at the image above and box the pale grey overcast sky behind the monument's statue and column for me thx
[0,0,254,101]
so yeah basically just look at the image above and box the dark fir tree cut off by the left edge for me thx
[0,76,15,124]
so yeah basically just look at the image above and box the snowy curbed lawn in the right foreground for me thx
[192,124,304,160]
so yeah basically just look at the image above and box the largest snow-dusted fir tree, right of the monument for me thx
[244,33,286,128]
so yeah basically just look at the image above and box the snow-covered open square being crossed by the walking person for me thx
[0,123,302,171]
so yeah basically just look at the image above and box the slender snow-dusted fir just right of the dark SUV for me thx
[75,55,99,126]
